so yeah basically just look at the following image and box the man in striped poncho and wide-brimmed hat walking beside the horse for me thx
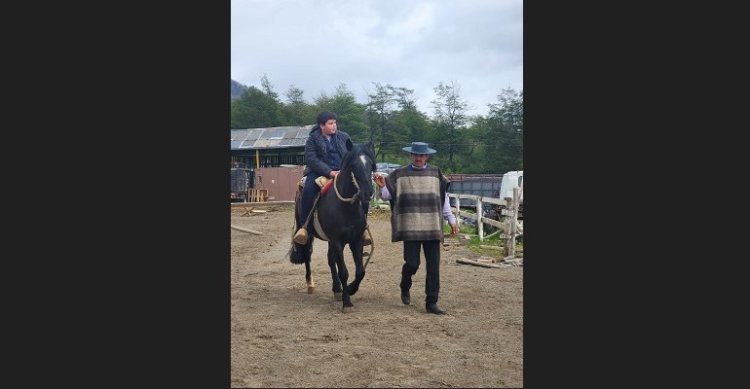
[375,142,458,315]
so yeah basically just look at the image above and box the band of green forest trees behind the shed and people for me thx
[231,74,523,174]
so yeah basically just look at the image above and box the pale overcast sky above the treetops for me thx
[231,0,523,116]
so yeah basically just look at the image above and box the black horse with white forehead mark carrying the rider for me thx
[288,140,376,312]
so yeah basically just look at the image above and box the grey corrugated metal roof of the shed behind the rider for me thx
[230,124,314,150]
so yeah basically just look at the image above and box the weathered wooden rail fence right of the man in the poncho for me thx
[448,188,523,257]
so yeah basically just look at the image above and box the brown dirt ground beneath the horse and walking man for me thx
[231,204,523,388]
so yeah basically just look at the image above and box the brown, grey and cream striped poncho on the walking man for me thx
[385,166,449,242]
